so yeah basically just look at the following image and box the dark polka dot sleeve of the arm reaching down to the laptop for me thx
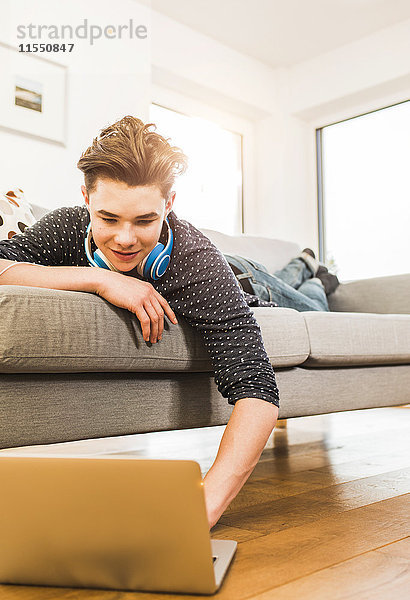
[159,238,279,406]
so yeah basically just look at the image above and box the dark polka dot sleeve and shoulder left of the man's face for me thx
[0,207,86,266]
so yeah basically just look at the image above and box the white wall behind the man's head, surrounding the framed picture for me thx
[0,0,151,209]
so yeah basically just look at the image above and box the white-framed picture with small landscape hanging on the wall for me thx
[0,42,68,146]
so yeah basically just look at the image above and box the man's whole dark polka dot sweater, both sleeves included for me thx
[0,205,279,406]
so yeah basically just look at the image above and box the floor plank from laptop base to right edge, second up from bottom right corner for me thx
[211,494,410,600]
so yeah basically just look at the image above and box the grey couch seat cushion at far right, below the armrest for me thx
[301,311,410,367]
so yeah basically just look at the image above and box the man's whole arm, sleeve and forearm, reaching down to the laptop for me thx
[154,237,279,526]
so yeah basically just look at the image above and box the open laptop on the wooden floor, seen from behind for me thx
[0,455,237,594]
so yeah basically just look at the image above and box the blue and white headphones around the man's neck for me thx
[84,218,174,281]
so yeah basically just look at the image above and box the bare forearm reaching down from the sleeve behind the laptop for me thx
[204,398,279,528]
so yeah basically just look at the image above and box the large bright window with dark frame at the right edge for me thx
[318,102,410,281]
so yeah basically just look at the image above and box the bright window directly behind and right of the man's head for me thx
[150,104,243,235]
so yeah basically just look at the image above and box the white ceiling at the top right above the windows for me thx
[150,0,410,68]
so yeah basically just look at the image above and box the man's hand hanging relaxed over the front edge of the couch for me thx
[96,270,178,344]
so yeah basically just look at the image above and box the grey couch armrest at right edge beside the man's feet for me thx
[328,273,410,314]
